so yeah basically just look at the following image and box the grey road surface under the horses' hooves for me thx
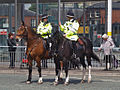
[0,72,120,90]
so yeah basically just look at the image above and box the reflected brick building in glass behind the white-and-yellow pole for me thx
[86,2,120,46]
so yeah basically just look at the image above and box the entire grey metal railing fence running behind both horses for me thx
[0,46,120,69]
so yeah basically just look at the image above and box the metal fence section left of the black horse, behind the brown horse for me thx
[0,46,55,68]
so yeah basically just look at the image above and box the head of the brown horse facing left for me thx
[16,25,28,40]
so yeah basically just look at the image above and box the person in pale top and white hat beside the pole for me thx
[99,34,115,70]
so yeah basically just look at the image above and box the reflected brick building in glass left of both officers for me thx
[0,4,36,46]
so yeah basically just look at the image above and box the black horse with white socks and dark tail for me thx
[53,30,100,85]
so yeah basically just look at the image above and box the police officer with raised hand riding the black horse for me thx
[59,12,79,52]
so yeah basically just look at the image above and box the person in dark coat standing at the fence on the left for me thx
[7,32,18,68]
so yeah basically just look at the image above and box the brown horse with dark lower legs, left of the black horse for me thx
[16,24,52,84]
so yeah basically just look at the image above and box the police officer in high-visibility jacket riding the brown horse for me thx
[37,14,52,50]
